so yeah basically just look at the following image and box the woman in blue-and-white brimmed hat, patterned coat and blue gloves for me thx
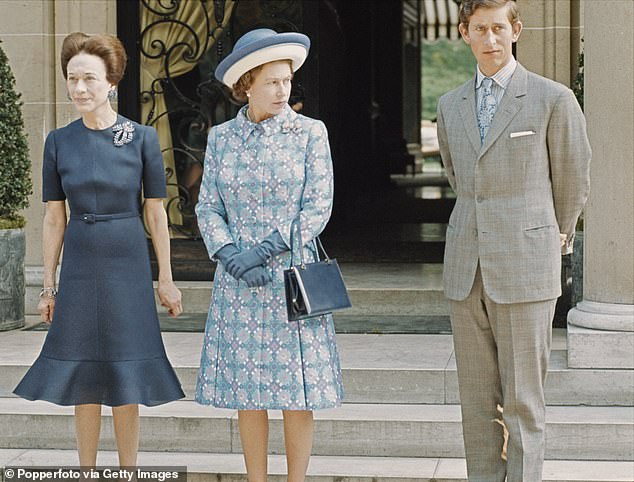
[196,29,343,482]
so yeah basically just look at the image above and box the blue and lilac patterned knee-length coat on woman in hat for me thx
[196,105,343,410]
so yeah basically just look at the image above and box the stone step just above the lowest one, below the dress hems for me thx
[0,398,634,461]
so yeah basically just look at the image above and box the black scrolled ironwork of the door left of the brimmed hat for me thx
[139,0,302,239]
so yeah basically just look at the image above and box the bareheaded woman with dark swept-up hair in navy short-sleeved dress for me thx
[15,32,184,466]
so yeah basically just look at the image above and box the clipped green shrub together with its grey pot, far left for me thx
[0,39,32,331]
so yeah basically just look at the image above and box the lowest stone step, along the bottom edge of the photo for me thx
[0,449,634,482]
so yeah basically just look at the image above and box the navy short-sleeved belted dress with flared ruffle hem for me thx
[14,116,184,406]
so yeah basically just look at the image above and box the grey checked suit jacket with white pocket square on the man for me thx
[438,63,591,303]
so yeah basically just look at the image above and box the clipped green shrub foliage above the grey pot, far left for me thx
[0,41,33,229]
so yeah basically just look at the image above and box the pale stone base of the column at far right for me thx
[568,301,634,369]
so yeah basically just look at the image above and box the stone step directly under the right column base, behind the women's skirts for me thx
[0,329,634,406]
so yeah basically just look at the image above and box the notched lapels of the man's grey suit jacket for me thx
[460,62,528,158]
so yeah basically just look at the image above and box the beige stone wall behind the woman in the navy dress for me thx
[0,0,116,314]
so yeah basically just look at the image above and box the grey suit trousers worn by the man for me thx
[450,267,556,482]
